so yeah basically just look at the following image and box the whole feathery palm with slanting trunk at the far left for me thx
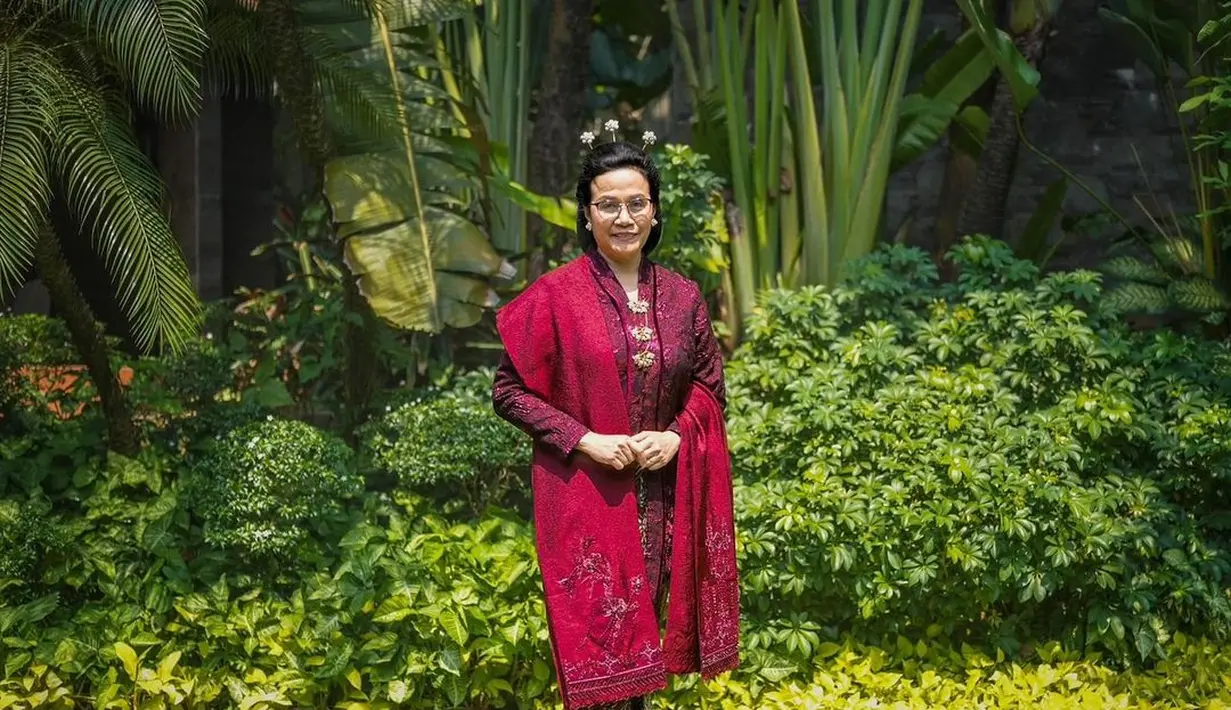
[0,0,206,453]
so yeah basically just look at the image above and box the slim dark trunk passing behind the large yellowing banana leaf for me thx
[261,0,380,444]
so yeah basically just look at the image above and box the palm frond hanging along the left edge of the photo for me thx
[0,41,53,295]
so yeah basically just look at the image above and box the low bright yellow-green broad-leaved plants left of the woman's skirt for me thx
[0,493,551,710]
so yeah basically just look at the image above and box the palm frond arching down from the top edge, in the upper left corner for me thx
[43,0,208,117]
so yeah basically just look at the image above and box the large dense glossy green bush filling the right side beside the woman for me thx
[729,235,1231,663]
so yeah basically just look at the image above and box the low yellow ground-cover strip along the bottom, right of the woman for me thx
[664,634,1231,710]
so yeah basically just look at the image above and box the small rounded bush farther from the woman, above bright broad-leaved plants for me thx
[193,417,362,555]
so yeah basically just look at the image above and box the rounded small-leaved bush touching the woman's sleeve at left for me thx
[361,369,531,509]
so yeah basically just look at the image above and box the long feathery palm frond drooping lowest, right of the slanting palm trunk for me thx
[52,69,199,349]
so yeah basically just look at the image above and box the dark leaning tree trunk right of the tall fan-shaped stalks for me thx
[956,20,1051,239]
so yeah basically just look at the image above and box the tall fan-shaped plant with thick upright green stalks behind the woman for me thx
[667,0,1009,334]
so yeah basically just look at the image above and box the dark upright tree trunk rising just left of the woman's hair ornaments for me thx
[527,0,595,279]
